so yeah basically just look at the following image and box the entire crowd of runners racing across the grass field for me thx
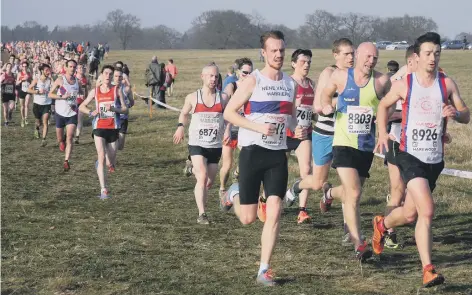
[1,31,470,287]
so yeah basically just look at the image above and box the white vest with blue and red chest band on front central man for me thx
[238,70,295,150]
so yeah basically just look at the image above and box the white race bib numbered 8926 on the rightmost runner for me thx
[407,122,441,152]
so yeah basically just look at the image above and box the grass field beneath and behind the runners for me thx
[1,50,472,295]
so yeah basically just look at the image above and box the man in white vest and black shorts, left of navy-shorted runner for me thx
[28,64,52,147]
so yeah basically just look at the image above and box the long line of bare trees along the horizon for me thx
[1,9,472,50]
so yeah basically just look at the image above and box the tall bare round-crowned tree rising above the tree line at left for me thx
[107,9,141,50]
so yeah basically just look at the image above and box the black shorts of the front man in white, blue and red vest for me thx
[239,145,288,205]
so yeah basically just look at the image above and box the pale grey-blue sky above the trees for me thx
[1,0,472,37]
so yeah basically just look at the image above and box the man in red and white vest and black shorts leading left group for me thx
[80,65,128,200]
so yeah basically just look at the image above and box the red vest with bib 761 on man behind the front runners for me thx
[287,79,315,138]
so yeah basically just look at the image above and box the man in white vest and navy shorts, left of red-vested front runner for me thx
[48,59,81,171]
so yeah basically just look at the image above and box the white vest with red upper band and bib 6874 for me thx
[188,89,224,148]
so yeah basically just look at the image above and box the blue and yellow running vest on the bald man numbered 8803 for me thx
[333,68,379,152]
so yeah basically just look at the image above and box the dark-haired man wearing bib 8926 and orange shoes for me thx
[372,32,470,287]
